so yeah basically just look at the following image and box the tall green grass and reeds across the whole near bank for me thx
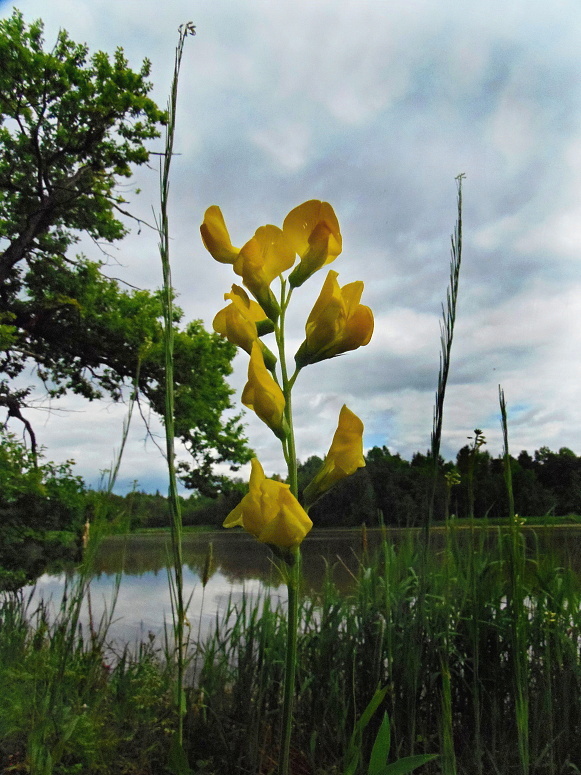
[0,526,581,775]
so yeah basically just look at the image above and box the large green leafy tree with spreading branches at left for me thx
[0,11,248,489]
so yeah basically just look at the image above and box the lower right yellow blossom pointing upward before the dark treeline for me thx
[303,404,365,507]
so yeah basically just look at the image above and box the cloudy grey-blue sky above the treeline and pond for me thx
[0,0,581,493]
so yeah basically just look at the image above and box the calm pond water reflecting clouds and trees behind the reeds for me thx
[23,527,581,647]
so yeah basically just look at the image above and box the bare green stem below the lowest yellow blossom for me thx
[279,547,301,775]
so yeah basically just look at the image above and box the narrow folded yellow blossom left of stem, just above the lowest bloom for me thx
[242,342,288,439]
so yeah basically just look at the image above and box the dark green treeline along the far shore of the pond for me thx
[112,445,581,530]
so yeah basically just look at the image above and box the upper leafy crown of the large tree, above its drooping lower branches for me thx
[0,11,165,286]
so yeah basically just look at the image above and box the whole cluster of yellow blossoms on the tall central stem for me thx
[200,200,373,550]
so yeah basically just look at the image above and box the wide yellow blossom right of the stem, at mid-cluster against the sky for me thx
[295,269,373,368]
